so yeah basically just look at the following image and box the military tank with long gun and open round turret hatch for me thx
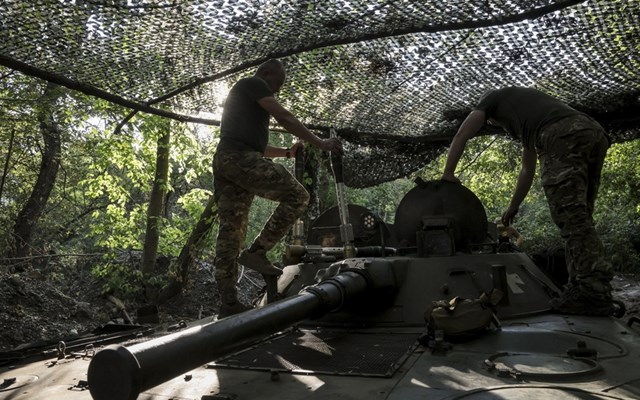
[0,174,640,400]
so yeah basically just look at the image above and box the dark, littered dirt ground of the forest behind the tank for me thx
[0,265,640,352]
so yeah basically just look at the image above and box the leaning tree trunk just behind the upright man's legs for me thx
[156,195,218,304]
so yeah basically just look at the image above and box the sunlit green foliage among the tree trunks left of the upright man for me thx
[0,72,220,292]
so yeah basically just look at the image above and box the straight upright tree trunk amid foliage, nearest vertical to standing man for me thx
[142,121,171,296]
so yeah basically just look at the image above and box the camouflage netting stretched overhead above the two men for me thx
[0,0,640,187]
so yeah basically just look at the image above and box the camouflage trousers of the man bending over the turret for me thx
[536,116,613,291]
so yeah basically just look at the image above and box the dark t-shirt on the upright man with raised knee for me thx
[217,76,273,153]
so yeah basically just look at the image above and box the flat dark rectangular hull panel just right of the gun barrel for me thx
[207,330,417,377]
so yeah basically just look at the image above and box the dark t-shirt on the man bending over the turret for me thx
[475,87,584,149]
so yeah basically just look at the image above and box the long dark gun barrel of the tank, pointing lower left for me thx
[88,270,371,400]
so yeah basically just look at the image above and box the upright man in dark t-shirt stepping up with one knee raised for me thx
[213,59,342,318]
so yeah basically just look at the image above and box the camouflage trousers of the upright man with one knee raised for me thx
[213,152,309,283]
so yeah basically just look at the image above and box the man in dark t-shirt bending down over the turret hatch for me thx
[442,87,617,315]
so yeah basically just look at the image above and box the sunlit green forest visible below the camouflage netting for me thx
[0,69,640,348]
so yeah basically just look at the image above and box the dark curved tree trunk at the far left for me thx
[7,83,63,270]
